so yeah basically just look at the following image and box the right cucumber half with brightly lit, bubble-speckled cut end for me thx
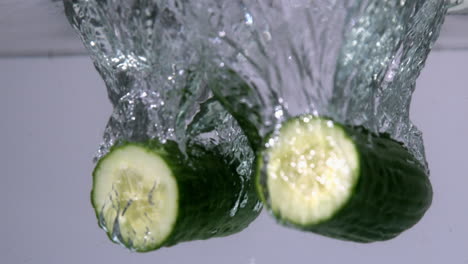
[256,115,432,242]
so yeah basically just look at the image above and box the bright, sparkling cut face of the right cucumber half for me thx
[265,116,359,226]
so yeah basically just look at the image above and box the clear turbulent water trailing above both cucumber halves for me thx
[64,0,449,250]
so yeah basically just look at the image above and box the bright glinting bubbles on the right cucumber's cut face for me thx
[263,115,350,200]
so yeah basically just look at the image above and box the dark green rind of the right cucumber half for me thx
[255,119,433,243]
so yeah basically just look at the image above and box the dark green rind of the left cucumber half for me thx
[91,141,260,252]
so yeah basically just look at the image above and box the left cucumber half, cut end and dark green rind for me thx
[91,141,260,252]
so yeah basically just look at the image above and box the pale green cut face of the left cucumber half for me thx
[92,144,178,252]
